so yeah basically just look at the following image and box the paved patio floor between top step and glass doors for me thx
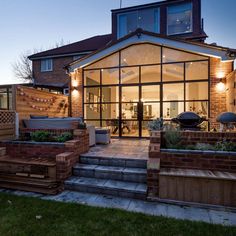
[86,139,149,160]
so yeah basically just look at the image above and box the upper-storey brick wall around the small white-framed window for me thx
[33,57,73,87]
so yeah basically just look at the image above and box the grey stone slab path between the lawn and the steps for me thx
[0,189,236,226]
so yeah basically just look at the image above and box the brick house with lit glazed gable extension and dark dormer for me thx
[30,0,236,137]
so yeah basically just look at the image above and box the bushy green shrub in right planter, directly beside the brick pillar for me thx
[164,124,182,149]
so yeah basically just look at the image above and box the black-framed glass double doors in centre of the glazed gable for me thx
[120,84,160,137]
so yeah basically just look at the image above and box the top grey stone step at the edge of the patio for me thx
[80,154,147,169]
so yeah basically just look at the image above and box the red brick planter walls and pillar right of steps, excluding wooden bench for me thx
[147,131,236,198]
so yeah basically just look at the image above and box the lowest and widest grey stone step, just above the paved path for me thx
[65,176,147,199]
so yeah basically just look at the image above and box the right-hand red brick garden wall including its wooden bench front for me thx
[147,131,236,206]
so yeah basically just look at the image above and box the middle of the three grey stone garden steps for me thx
[73,164,147,183]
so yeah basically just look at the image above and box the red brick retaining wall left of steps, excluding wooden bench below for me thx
[0,129,89,181]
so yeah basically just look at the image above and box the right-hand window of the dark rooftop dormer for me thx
[167,3,193,35]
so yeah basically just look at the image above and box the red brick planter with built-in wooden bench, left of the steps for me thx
[0,129,89,193]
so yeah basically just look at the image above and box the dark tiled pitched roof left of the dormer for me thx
[29,34,112,60]
